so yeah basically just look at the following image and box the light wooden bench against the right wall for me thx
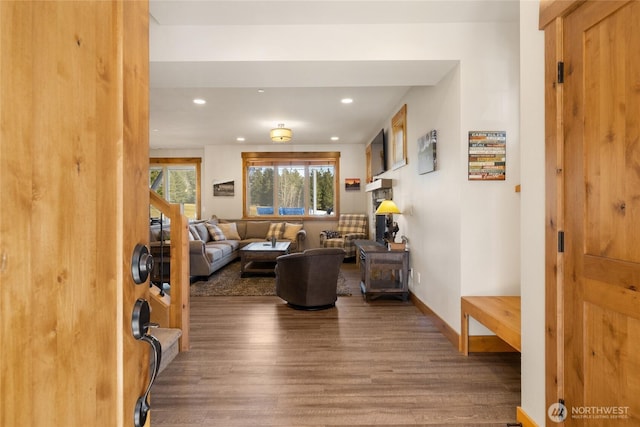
[460,296,522,356]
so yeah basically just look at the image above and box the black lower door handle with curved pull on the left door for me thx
[131,298,162,427]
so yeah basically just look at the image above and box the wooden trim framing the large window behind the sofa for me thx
[242,151,340,221]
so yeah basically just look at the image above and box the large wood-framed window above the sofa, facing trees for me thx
[242,152,340,218]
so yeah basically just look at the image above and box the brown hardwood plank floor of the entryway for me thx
[151,264,520,427]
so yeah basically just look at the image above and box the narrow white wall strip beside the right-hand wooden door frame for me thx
[520,0,546,426]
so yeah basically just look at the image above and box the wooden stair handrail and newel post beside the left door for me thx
[149,190,190,351]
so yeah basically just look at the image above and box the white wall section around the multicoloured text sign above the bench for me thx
[460,21,520,300]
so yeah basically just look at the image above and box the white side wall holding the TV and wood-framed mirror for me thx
[381,67,462,328]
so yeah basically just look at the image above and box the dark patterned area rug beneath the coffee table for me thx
[191,261,351,297]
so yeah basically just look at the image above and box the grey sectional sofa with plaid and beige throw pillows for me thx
[150,217,307,281]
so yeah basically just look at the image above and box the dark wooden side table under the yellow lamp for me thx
[355,240,409,301]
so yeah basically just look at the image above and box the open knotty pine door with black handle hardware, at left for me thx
[0,1,149,427]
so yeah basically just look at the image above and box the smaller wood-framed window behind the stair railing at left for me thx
[149,158,201,219]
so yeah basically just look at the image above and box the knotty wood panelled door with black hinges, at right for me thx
[561,1,640,425]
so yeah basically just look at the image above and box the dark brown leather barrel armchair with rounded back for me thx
[276,248,345,310]
